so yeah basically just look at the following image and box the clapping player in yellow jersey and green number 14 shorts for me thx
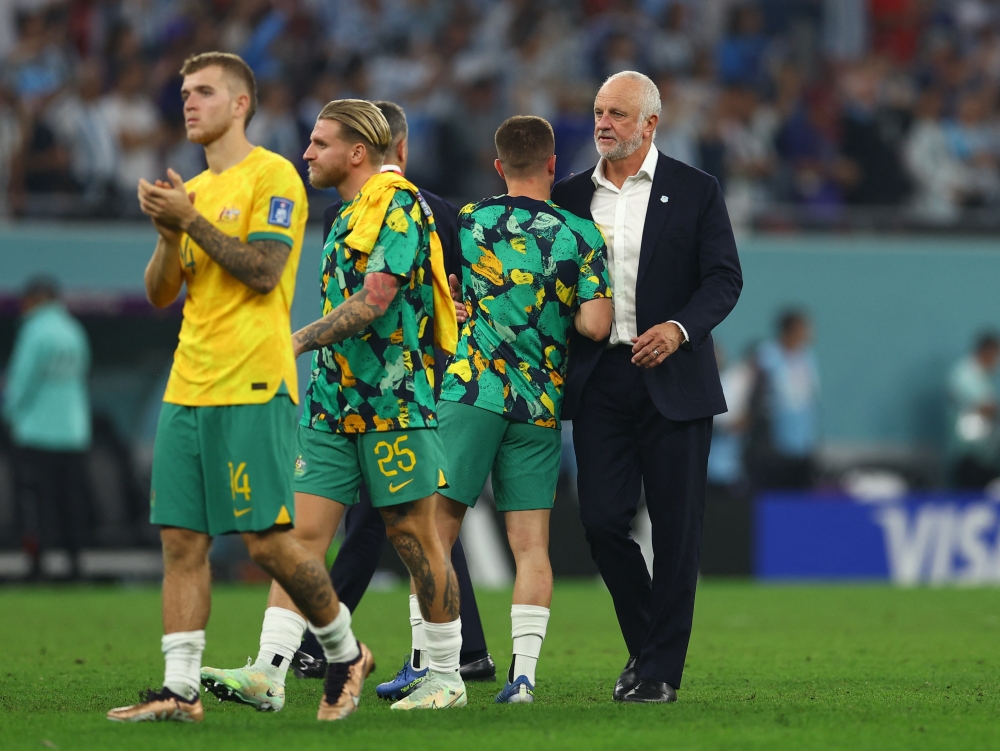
[108,52,371,722]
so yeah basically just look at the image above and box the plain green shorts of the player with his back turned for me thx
[438,400,562,511]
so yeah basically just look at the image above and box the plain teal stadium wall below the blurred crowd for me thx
[0,223,1000,446]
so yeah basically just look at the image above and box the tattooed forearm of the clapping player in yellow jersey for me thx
[187,216,292,295]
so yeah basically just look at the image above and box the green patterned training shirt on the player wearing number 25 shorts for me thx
[301,188,437,433]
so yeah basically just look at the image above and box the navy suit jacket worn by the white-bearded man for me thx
[552,152,743,420]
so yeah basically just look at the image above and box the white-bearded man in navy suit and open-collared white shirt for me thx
[552,71,743,702]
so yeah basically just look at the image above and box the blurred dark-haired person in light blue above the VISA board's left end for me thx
[754,310,820,489]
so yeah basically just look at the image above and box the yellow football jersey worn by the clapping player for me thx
[163,146,309,407]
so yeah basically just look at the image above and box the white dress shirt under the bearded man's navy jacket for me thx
[590,147,688,347]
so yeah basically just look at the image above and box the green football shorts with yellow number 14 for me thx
[149,396,297,536]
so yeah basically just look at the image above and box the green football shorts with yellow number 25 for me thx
[294,425,448,508]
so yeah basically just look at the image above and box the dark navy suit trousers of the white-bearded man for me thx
[573,346,712,688]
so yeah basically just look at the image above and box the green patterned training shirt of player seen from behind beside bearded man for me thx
[441,196,611,428]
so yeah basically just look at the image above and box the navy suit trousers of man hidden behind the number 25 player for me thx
[303,486,487,664]
